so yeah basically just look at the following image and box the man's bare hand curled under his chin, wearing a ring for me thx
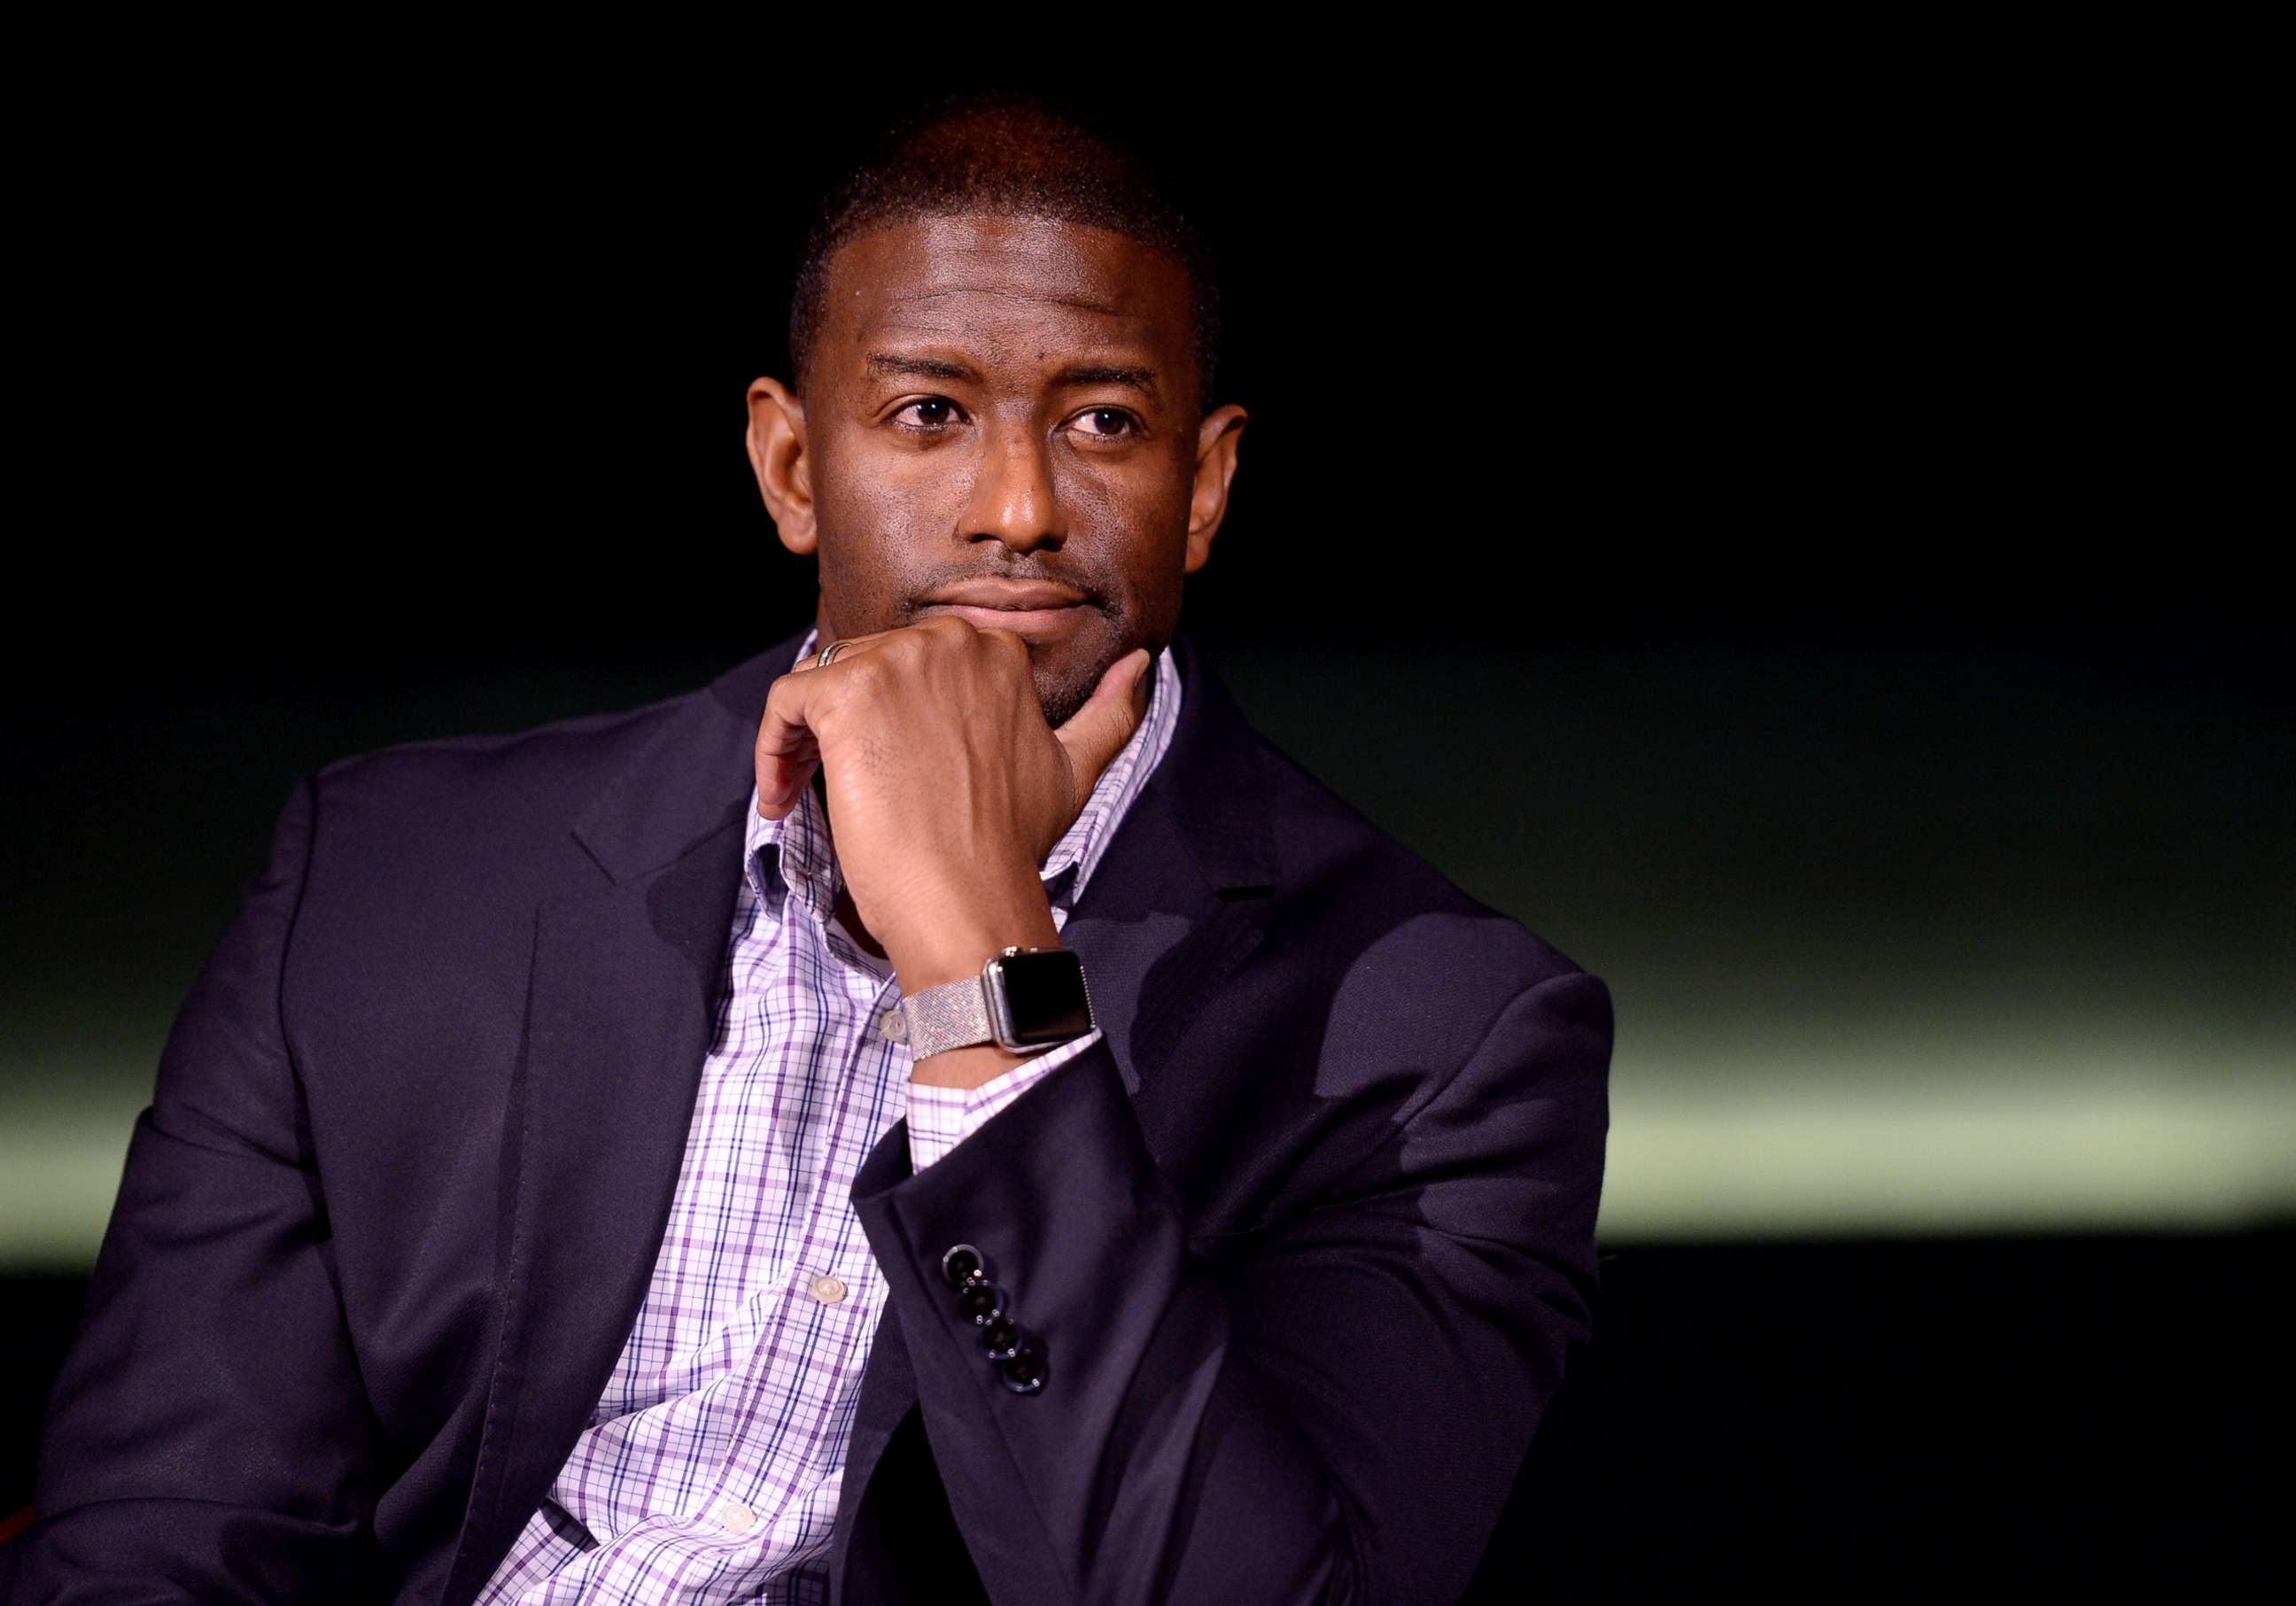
[757,616,1152,992]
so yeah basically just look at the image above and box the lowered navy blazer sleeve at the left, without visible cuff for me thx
[7,779,376,1606]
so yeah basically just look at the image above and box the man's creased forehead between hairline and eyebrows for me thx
[829,213,1190,340]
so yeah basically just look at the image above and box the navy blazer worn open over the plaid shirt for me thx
[0,632,1612,1606]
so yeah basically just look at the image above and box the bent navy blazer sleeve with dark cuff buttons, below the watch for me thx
[854,970,1612,1606]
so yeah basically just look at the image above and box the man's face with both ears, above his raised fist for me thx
[751,216,1245,726]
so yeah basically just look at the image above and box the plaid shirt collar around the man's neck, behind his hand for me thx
[741,630,1180,921]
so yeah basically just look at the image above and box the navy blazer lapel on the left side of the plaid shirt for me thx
[443,636,802,1602]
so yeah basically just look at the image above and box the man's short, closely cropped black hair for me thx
[790,89,1219,415]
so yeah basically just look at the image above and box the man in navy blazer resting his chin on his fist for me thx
[4,101,1610,1603]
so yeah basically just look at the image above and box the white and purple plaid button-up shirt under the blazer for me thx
[477,632,1180,1606]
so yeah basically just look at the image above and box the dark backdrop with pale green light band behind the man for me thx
[0,42,2296,1599]
